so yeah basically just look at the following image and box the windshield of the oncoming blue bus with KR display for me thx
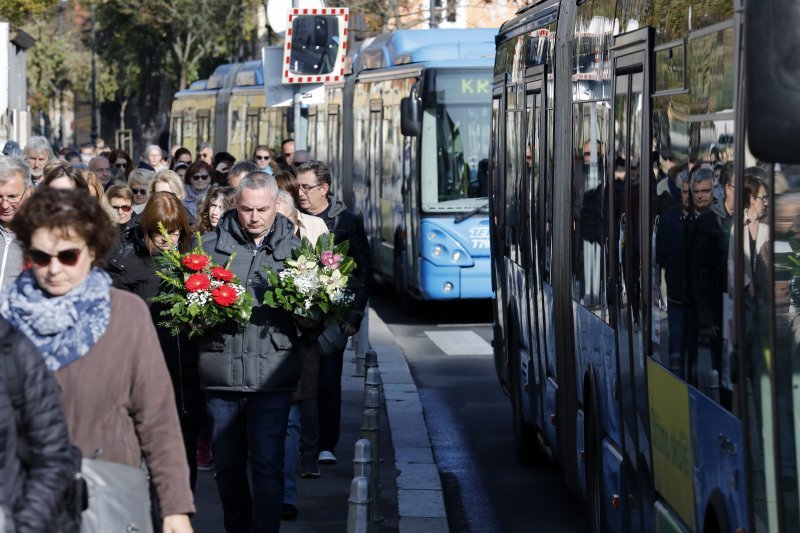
[420,69,492,212]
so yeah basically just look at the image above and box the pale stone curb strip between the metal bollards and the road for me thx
[369,309,450,533]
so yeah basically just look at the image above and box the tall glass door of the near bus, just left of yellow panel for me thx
[607,29,652,531]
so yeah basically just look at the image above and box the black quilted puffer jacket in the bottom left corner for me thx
[0,318,78,533]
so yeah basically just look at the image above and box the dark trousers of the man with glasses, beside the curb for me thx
[317,347,344,453]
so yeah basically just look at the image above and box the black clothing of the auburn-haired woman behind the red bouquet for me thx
[107,223,205,423]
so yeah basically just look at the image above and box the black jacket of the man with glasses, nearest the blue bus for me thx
[322,194,372,329]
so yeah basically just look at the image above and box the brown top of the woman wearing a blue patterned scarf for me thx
[56,288,195,516]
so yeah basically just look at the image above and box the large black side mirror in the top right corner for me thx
[744,0,800,163]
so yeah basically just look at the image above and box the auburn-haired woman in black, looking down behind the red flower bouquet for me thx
[108,192,205,488]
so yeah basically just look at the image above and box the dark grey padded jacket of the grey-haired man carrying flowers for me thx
[198,209,300,392]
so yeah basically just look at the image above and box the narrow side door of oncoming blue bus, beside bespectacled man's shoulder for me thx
[364,98,383,265]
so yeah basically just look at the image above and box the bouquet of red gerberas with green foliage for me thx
[150,223,253,337]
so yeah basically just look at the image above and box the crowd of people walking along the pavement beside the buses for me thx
[0,137,372,533]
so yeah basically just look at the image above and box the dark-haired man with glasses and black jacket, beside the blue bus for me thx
[295,161,372,464]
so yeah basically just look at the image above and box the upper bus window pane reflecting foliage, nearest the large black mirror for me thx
[688,28,734,115]
